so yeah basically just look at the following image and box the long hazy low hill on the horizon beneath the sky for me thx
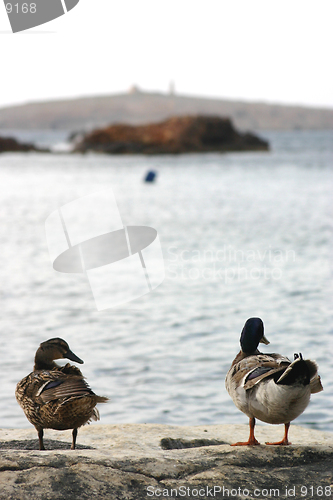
[0,88,333,133]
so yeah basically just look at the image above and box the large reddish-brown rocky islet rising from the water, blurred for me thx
[75,116,268,155]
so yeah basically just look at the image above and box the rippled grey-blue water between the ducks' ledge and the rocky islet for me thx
[0,131,333,431]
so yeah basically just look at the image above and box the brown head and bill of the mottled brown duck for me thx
[34,338,83,370]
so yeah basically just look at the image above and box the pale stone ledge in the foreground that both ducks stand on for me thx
[0,424,333,500]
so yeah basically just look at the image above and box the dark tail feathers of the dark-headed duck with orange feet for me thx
[276,354,321,386]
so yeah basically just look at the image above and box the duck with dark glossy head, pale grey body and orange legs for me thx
[225,318,323,446]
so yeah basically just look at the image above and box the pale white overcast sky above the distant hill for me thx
[0,0,333,108]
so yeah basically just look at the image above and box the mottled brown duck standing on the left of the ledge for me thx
[15,338,108,450]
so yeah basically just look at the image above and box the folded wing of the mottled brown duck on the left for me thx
[36,375,94,403]
